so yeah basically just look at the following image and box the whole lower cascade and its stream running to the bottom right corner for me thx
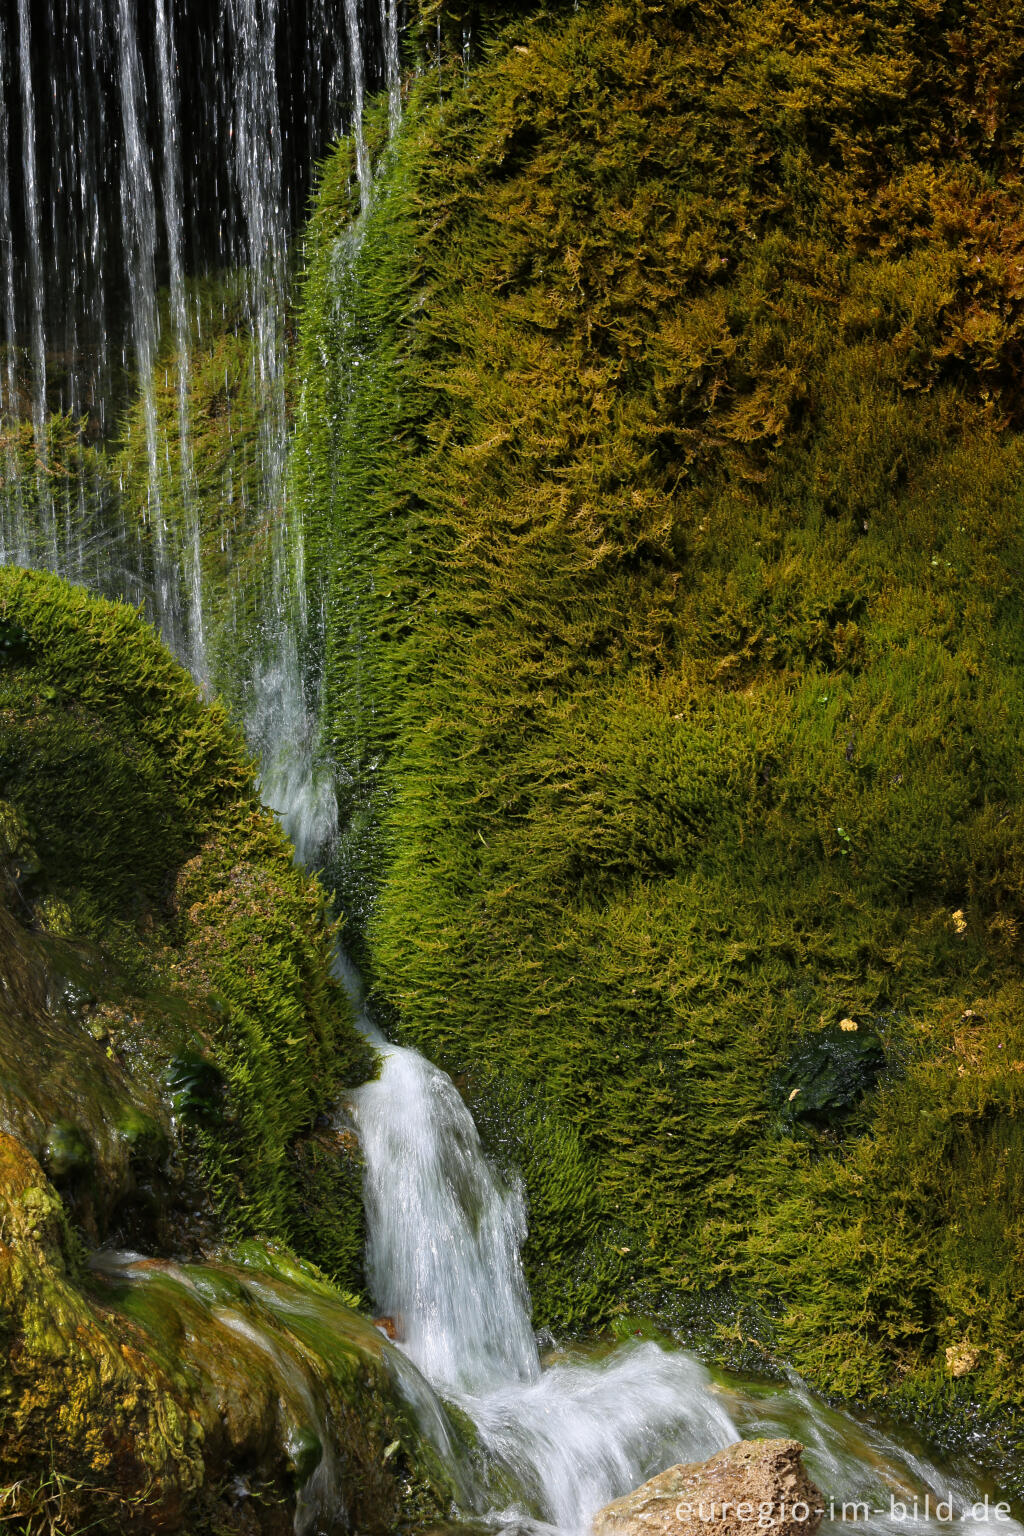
[328,957,1024,1536]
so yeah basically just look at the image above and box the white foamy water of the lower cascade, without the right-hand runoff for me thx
[350,1035,738,1531]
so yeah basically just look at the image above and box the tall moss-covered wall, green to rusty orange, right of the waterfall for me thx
[296,0,1024,1493]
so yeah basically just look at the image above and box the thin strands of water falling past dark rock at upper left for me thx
[0,0,401,755]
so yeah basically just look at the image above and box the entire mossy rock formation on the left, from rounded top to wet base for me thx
[0,570,450,1531]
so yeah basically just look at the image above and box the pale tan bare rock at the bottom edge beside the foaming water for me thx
[593,1439,824,1536]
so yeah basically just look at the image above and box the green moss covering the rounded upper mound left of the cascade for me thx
[0,570,372,1290]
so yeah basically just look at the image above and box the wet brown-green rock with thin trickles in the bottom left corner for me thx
[0,1134,451,1536]
